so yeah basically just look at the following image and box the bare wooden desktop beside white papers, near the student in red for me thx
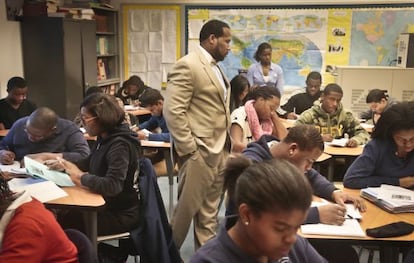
[46,186,105,208]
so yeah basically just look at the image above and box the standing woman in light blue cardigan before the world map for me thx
[247,42,285,94]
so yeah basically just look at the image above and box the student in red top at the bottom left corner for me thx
[0,176,78,263]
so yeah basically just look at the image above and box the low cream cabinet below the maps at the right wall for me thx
[336,66,414,115]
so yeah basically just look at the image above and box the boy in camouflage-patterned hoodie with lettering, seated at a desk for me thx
[296,83,369,147]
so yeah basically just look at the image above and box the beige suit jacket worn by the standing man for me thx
[163,49,230,167]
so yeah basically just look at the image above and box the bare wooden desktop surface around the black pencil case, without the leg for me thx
[299,189,414,241]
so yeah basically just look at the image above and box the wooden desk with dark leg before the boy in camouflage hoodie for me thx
[324,145,364,182]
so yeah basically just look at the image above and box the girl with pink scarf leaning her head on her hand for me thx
[230,86,287,152]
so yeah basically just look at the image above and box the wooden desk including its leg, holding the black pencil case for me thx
[299,185,414,263]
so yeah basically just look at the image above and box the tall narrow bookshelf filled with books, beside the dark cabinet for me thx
[93,7,120,93]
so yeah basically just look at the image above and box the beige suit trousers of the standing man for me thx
[171,150,228,250]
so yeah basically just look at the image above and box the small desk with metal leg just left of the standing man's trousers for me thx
[141,140,174,218]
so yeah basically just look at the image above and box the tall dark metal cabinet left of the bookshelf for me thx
[21,17,97,119]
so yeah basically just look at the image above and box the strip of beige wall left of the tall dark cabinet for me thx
[0,0,23,98]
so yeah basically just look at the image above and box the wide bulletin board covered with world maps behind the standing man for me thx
[185,4,414,90]
